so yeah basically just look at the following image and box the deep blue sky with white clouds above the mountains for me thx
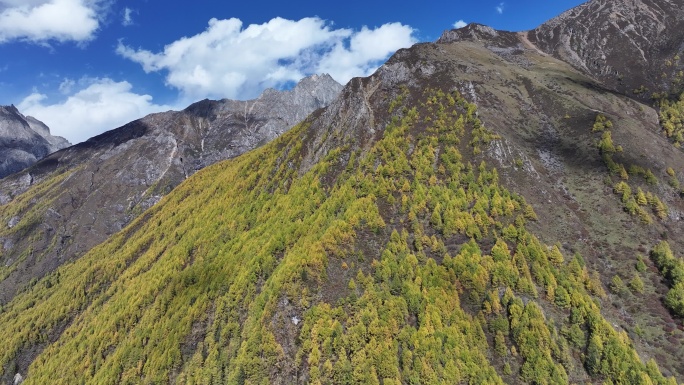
[0,0,583,143]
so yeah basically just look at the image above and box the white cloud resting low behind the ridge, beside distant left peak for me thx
[17,78,172,144]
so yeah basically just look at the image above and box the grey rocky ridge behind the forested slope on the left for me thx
[0,75,342,304]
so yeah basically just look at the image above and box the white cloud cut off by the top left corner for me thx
[0,0,106,43]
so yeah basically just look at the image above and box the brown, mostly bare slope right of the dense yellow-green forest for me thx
[432,25,684,373]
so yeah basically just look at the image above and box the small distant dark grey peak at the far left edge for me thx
[0,106,71,178]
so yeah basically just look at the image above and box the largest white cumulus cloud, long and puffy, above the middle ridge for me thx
[117,17,416,100]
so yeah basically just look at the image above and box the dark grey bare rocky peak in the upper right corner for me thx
[528,0,684,97]
